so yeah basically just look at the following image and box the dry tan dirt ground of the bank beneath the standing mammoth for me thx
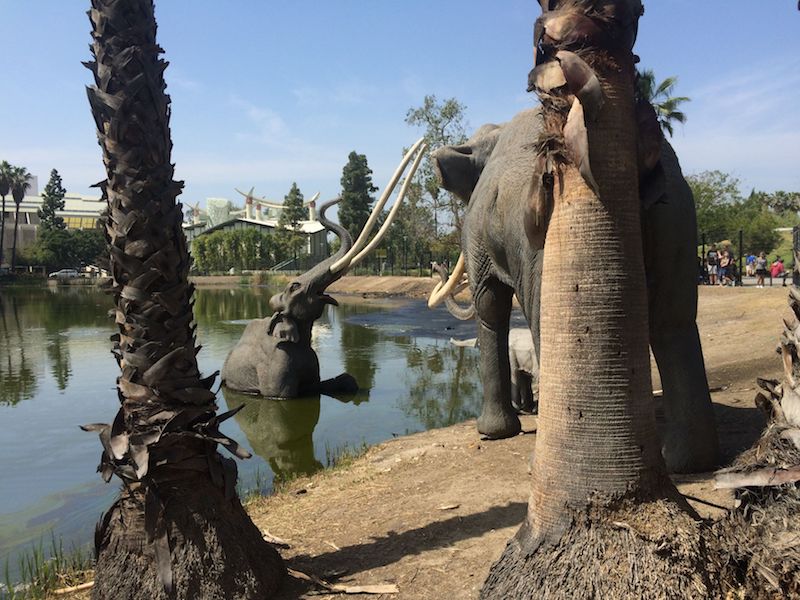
[67,277,787,600]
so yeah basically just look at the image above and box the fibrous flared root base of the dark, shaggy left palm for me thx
[92,481,285,600]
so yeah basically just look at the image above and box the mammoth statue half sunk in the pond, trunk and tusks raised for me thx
[221,140,426,398]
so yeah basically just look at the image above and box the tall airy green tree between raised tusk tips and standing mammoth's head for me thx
[406,95,467,237]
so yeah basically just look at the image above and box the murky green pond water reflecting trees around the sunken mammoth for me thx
[0,287,494,567]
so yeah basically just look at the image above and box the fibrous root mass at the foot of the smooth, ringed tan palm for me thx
[481,500,718,600]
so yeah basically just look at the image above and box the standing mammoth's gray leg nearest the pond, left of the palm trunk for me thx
[475,279,522,439]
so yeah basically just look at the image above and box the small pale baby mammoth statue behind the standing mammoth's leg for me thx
[450,327,539,413]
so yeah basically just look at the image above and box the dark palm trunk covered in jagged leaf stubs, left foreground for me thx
[87,0,284,599]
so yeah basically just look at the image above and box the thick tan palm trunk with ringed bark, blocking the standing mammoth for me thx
[482,0,710,599]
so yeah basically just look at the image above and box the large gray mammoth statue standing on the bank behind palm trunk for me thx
[434,109,719,472]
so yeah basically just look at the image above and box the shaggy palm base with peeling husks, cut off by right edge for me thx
[714,278,800,600]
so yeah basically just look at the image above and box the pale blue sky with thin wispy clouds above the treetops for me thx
[0,0,800,204]
